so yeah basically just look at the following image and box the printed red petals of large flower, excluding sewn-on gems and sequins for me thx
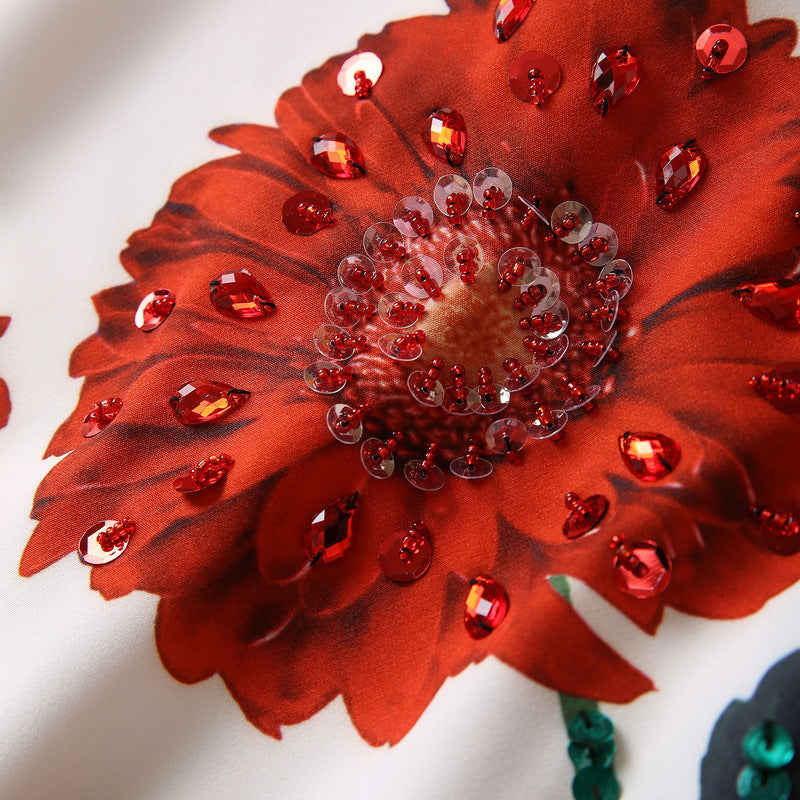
[20,0,800,744]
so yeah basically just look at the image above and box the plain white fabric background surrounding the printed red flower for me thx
[0,0,800,800]
